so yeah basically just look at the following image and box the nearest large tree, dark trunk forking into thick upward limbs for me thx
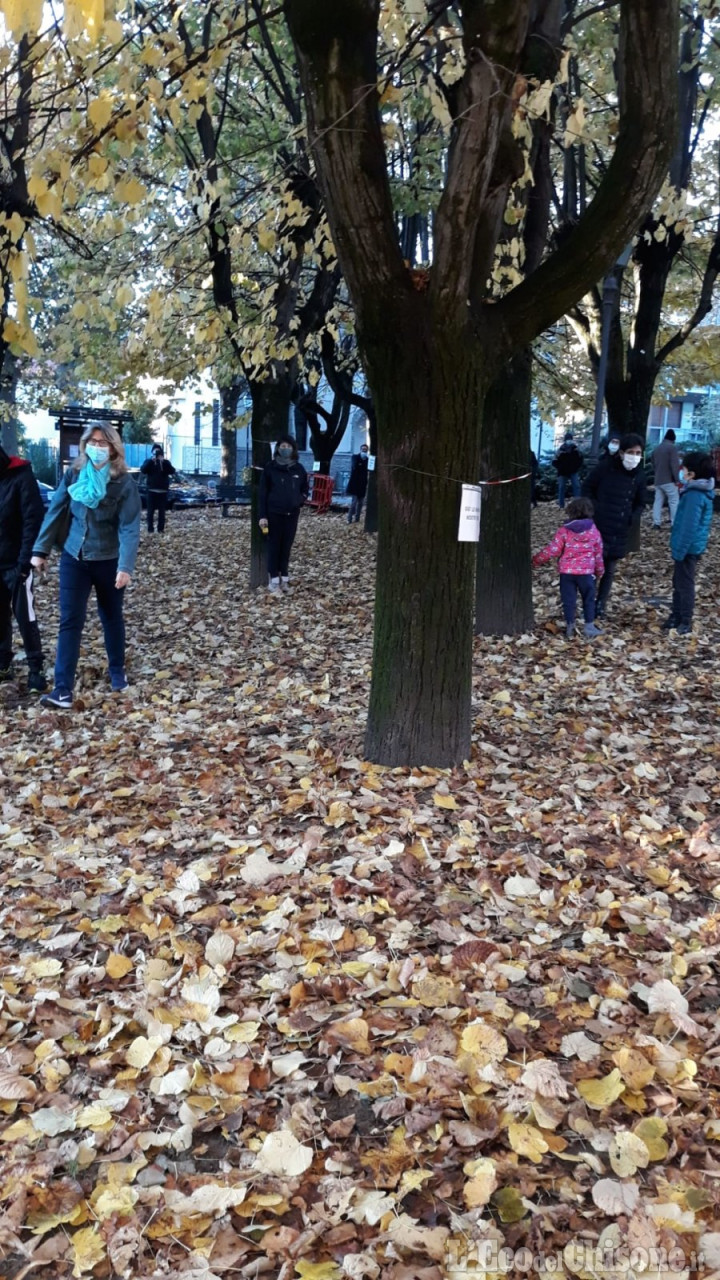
[284,0,678,765]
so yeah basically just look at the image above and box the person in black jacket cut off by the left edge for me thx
[0,448,47,694]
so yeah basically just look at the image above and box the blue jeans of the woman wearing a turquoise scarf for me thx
[55,552,126,694]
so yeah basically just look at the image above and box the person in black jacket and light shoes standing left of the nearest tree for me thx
[259,435,307,594]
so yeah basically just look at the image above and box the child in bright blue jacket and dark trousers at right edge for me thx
[662,452,715,635]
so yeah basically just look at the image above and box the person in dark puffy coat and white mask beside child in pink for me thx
[583,434,648,618]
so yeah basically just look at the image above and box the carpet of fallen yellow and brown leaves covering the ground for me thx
[0,508,720,1280]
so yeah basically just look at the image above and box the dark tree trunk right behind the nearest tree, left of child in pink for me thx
[475,348,534,636]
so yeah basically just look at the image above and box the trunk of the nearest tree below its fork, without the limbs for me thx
[365,325,484,768]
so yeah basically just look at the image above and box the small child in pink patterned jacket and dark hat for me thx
[533,498,605,640]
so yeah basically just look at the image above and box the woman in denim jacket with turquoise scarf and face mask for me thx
[32,422,140,709]
